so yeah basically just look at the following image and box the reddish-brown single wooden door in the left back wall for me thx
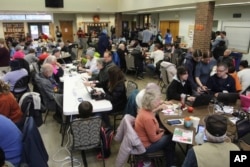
[59,21,74,42]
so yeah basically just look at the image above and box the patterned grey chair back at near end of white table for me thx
[70,117,102,150]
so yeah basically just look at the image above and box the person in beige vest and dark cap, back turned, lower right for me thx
[182,115,240,167]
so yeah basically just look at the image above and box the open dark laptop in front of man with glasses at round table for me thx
[217,93,239,105]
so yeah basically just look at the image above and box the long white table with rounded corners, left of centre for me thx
[63,74,112,115]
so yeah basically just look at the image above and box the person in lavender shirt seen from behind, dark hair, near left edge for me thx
[2,60,28,91]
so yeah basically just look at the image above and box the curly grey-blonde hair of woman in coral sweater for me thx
[141,83,161,111]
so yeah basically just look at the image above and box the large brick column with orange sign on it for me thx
[193,1,215,51]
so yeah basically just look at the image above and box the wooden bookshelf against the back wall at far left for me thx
[3,23,25,39]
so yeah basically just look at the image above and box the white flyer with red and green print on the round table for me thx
[172,128,193,144]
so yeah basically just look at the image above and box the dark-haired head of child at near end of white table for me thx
[78,101,93,118]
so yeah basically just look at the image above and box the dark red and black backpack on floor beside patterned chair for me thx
[101,127,114,158]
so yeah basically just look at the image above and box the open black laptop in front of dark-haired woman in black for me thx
[186,94,212,107]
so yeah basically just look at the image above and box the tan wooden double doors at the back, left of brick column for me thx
[160,21,179,41]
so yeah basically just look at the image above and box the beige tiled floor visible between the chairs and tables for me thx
[39,71,183,167]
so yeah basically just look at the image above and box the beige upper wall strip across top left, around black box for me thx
[0,0,117,13]
